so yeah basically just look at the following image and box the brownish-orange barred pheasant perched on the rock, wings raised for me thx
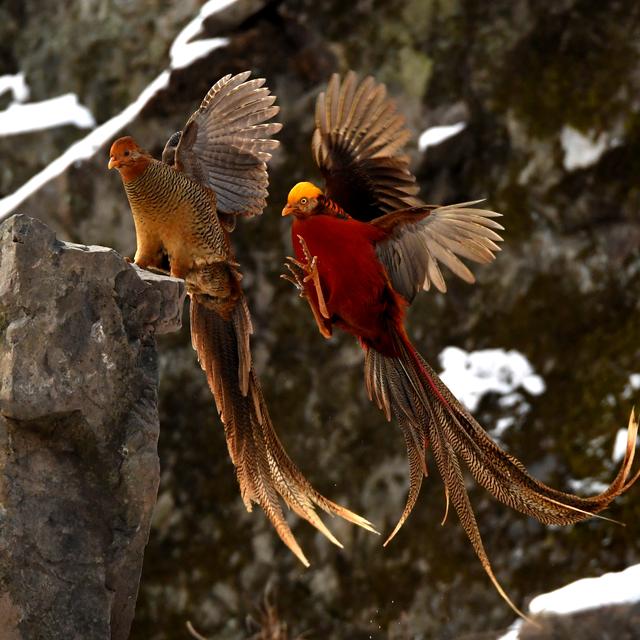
[109,71,371,565]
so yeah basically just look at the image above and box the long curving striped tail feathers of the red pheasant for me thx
[365,331,640,619]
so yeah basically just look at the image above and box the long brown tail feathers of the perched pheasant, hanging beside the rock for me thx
[191,295,377,566]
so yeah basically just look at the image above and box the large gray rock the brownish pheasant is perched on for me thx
[0,215,184,640]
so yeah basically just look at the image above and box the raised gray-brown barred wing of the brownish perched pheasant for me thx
[171,71,282,216]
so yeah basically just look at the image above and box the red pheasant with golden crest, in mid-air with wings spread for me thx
[282,72,638,615]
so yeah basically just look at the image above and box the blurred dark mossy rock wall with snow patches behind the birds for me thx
[0,0,640,640]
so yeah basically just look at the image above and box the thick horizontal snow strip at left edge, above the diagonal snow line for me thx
[0,92,96,136]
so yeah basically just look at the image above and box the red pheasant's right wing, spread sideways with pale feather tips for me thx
[371,200,504,302]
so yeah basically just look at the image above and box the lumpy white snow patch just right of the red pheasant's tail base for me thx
[440,347,545,412]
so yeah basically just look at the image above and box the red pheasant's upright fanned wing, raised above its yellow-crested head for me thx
[311,71,422,221]
